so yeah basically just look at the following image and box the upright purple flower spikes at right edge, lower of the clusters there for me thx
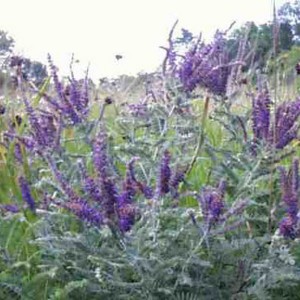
[279,159,299,239]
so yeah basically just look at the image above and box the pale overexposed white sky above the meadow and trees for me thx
[0,0,286,80]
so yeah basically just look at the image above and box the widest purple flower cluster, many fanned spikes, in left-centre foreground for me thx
[46,129,183,232]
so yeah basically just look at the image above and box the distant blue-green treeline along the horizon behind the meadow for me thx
[0,0,300,86]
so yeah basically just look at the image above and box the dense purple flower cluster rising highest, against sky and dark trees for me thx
[173,32,232,96]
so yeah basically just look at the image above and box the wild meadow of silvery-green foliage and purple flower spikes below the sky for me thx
[0,17,300,300]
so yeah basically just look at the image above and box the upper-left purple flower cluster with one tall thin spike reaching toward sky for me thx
[46,55,89,125]
